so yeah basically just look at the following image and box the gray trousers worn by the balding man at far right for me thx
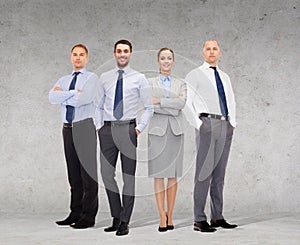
[194,117,234,222]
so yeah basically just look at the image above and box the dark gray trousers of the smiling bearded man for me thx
[98,123,137,223]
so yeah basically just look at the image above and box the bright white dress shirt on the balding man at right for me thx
[184,62,236,129]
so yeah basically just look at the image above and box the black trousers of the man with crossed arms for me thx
[62,118,98,221]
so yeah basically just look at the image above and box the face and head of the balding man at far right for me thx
[202,40,222,66]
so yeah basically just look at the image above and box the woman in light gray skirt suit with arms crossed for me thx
[148,48,187,232]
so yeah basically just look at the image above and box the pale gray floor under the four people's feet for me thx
[0,213,300,245]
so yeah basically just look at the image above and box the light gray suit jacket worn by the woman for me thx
[148,76,187,136]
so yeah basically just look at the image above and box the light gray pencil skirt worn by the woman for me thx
[148,125,184,178]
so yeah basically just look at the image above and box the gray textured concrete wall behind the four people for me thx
[0,0,300,215]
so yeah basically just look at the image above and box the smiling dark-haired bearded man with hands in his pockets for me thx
[96,40,154,236]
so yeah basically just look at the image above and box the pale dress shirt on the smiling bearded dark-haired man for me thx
[96,67,154,132]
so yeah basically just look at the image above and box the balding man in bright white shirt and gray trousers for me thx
[186,40,237,232]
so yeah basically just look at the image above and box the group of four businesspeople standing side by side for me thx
[49,40,237,236]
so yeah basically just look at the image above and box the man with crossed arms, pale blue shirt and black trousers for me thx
[49,44,98,229]
